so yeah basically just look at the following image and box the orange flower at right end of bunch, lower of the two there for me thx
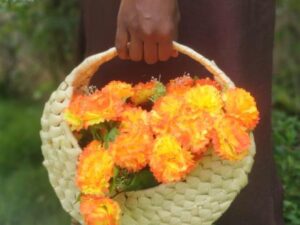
[212,115,250,161]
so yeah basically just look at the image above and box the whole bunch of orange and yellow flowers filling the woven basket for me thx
[65,75,259,225]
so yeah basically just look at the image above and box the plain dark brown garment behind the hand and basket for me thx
[78,0,283,225]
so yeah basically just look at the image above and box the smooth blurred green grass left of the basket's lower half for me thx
[0,98,70,225]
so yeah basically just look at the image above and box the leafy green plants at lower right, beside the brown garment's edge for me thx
[273,111,300,225]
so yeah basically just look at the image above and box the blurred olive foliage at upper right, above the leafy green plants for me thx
[273,0,300,114]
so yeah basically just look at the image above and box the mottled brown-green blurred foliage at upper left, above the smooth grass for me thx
[0,0,79,99]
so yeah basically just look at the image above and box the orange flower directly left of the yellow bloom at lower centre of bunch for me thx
[109,130,153,172]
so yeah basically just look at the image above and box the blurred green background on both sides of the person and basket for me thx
[0,0,300,225]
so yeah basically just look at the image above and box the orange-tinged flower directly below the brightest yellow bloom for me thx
[171,110,213,156]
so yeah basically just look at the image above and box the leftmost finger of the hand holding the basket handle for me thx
[115,26,129,59]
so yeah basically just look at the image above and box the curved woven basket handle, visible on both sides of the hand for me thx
[66,42,234,89]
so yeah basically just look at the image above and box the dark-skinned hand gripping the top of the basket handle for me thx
[115,0,180,64]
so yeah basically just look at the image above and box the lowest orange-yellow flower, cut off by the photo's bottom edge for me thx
[80,195,121,225]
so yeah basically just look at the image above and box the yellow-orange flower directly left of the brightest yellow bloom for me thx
[150,95,182,134]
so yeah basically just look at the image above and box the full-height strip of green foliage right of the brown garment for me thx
[272,0,300,225]
